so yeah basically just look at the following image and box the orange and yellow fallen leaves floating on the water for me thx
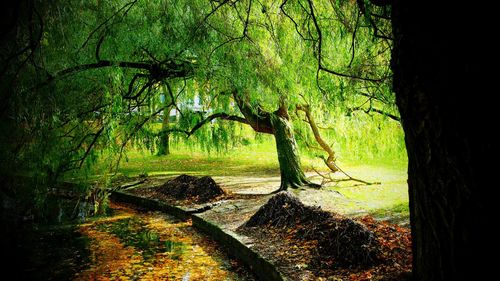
[75,202,252,280]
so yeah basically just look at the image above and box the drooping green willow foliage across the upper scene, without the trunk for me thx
[0,0,405,217]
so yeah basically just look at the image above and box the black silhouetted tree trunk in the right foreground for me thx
[392,0,498,280]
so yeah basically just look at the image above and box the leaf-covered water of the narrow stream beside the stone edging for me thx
[19,200,254,281]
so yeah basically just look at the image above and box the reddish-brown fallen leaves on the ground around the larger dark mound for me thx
[241,210,412,281]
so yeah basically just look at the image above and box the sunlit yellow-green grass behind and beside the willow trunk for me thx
[107,139,409,221]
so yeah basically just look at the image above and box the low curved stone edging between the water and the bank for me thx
[111,191,286,281]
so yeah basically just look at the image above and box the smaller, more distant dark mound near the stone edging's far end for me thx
[159,175,224,203]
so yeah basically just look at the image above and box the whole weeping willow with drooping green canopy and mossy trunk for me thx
[2,0,394,214]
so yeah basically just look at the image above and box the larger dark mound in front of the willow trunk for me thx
[242,192,380,266]
